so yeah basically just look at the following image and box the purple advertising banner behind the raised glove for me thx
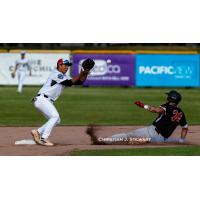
[73,54,135,86]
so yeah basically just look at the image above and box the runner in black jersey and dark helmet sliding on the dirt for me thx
[87,90,188,144]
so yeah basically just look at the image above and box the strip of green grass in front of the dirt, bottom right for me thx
[70,146,200,156]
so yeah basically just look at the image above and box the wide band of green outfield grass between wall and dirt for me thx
[0,87,200,126]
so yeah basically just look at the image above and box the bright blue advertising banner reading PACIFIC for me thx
[136,54,200,87]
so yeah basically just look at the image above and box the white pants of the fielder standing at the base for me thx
[34,94,60,139]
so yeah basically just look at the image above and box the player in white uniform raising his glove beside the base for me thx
[31,59,94,146]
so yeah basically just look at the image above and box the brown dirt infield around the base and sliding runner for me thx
[0,126,200,156]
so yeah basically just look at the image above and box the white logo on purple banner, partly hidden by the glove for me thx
[79,60,121,76]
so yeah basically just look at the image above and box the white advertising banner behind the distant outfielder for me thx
[0,53,70,85]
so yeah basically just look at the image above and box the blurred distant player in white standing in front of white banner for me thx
[13,51,31,94]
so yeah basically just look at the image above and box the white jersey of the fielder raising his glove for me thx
[39,69,72,101]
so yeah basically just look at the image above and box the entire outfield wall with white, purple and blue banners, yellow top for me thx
[0,50,200,87]
